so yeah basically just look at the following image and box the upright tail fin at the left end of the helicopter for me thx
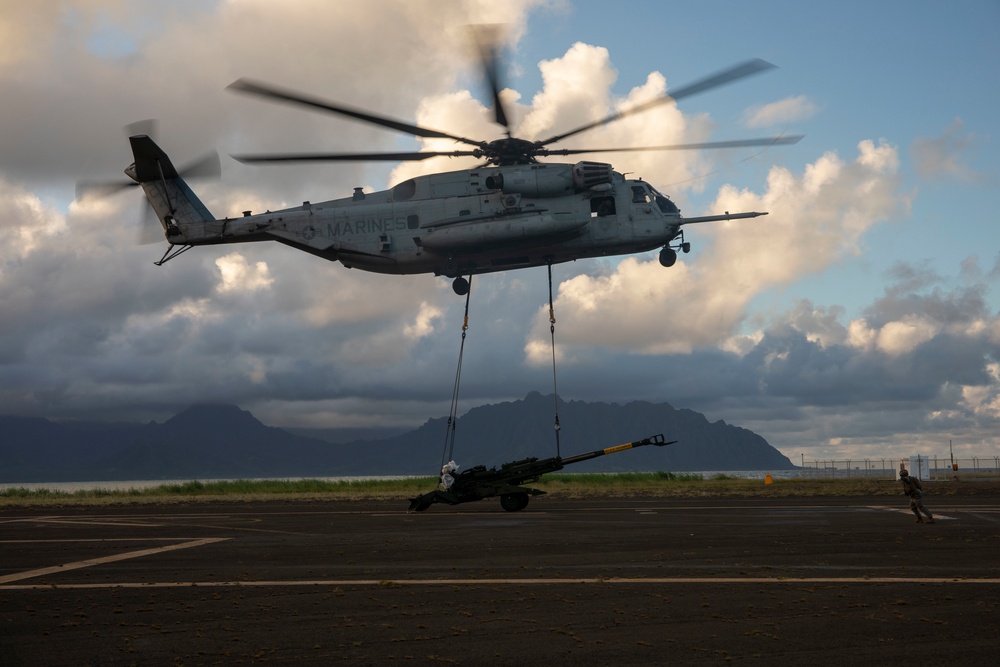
[125,134,217,240]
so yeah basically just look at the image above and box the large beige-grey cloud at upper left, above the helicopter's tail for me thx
[0,0,536,193]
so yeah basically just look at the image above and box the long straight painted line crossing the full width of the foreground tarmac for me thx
[0,576,1000,590]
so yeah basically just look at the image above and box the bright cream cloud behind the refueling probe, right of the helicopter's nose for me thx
[527,140,906,360]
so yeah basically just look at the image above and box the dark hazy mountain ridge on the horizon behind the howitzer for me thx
[0,392,795,484]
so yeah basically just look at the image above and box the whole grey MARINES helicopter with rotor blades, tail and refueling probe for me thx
[82,38,801,295]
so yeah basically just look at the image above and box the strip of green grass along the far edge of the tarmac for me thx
[0,472,1000,507]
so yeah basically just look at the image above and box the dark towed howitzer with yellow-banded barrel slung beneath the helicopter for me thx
[409,433,677,512]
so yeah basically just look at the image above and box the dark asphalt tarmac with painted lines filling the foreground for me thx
[0,496,1000,666]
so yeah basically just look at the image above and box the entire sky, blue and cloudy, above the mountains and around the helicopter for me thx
[0,0,1000,461]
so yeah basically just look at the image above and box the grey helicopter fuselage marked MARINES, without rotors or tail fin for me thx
[168,162,685,286]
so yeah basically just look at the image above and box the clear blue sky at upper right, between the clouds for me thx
[515,0,1000,314]
